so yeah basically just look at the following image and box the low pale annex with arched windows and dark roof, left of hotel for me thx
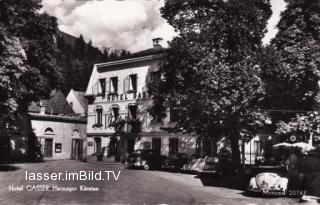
[28,90,87,160]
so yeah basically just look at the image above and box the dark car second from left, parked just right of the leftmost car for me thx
[161,153,188,171]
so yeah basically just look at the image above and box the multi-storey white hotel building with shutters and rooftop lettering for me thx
[86,38,196,162]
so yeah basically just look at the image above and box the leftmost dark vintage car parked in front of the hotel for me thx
[126,149,166,170]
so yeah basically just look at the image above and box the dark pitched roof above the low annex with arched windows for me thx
[28,90,75,115]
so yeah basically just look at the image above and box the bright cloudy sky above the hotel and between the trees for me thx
[42,0,285,52]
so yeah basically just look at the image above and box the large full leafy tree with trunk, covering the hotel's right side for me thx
[148,0,271,164]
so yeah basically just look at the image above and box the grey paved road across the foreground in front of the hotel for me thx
[0,160,312,205]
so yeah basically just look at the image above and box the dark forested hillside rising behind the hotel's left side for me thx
[57,31,130,95]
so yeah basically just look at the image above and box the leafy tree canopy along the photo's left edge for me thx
[0,0,58,118]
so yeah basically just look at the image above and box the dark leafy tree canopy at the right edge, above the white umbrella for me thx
[272,0,320,111]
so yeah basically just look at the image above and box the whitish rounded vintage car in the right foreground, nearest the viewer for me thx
[247,166,289,195]
